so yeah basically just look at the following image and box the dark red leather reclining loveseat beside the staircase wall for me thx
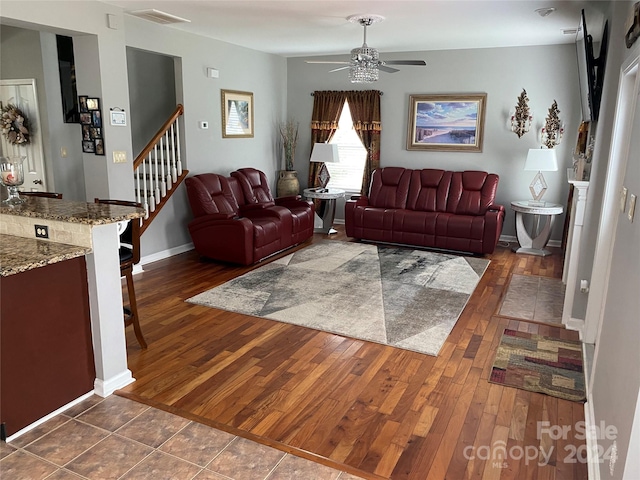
[185,168,314,265]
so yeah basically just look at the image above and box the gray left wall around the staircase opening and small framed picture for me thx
[124,16,287,256]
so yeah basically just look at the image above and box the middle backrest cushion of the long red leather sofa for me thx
[407,168,452,212]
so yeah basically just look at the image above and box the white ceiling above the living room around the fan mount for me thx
[105,0,606,57]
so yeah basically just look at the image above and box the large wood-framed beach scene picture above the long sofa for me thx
[407,93,487,152]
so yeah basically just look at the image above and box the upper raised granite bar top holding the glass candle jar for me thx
[0,196,145,225]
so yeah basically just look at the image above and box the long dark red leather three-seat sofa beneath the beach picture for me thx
[345,167,505,254]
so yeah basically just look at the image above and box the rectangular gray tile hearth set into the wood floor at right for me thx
[498,274,565,325]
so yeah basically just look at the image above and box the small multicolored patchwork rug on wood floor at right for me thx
[489,329,586,402]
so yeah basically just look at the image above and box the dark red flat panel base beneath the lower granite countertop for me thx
[0,257,96,436]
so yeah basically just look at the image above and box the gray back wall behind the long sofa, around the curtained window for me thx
[287,45,581,240]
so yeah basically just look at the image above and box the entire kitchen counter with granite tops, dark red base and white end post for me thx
[0,197,145,439]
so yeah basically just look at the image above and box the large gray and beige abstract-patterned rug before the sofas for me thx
[187,241,489,355]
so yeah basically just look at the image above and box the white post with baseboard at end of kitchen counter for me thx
[86,223,135,397]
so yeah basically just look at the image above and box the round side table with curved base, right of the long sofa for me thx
[511,200,564,257]
